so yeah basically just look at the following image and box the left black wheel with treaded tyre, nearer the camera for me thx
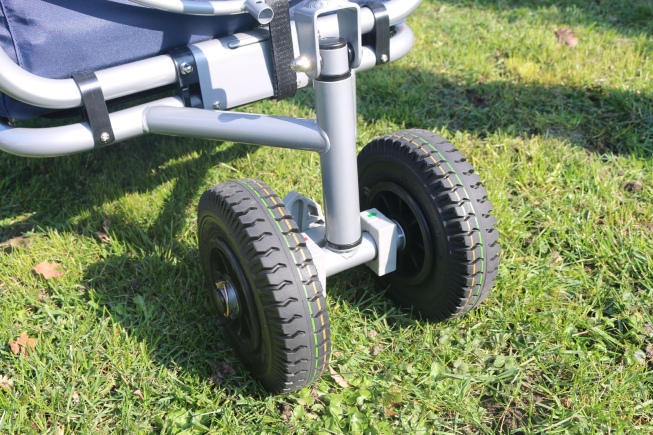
[198,179,331,393]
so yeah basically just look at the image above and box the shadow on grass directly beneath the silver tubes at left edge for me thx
[0,131,257,243]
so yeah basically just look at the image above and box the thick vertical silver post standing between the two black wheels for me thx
[314,38,362,251]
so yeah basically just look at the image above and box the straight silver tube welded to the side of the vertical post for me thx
[143,107,329,153]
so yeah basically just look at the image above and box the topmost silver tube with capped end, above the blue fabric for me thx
[131,0,274,25]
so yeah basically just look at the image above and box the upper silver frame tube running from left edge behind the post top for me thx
[0,0,422,109]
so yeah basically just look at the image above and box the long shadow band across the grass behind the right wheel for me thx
[358,66,653,159]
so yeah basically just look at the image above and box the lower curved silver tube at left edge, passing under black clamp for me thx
[0,97,184,157]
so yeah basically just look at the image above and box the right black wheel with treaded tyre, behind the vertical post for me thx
[358,130,499,321]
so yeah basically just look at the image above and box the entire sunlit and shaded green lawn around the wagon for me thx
[0,0,653,434]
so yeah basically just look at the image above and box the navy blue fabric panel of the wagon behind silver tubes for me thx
[0,0,257,119]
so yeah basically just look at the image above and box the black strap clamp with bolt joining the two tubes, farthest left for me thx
[72,71,116,147]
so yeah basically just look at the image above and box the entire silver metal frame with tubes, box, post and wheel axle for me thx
[0,0,421,281]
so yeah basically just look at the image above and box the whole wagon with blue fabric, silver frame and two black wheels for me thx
[0,0,499,393]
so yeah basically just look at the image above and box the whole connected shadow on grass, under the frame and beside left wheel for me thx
[0,129,268,396]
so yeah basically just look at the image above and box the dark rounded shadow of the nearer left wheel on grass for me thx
[84,250,267,398]
